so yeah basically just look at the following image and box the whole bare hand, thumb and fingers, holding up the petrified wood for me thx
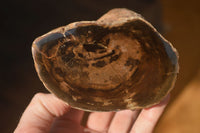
[14,93,169,133]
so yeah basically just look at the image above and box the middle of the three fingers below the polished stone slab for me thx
[108,110,139,133]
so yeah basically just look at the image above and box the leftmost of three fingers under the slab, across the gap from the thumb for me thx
[87,112,114,132]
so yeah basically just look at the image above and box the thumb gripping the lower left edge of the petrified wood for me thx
[15,93,70,133]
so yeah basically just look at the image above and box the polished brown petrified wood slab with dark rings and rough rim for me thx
[32,9,178,111]
